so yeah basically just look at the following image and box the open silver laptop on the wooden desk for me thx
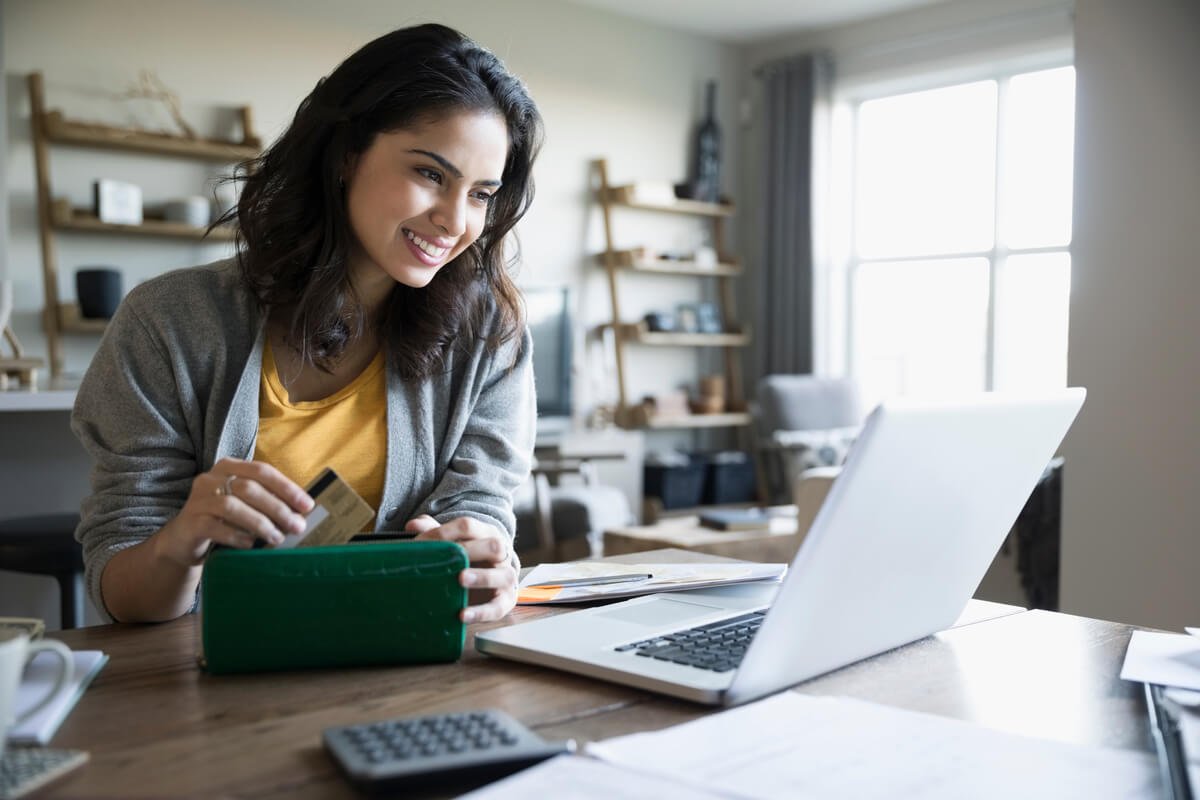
[475,389,1085,705]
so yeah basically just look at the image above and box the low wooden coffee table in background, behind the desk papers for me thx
[604,516,804,564]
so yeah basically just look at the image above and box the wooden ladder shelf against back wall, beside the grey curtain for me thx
[594,158,750,438]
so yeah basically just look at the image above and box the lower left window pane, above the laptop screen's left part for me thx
[852,258,989,404]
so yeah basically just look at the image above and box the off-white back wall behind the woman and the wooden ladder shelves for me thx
[4,0,738,422]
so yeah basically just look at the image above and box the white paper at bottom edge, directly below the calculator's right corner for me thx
[462,756,727,800]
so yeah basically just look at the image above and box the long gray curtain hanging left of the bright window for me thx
[755,53,833,375]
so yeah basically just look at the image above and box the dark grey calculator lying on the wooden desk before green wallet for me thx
[322,709,575,789]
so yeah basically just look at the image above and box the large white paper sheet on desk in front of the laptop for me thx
[587,692,1160,800]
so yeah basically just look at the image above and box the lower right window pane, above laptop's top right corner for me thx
[996,253,1070,390]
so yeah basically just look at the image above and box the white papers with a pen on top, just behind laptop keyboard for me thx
[518,561,787,604]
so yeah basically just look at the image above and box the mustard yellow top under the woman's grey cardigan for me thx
[254,339,388,522]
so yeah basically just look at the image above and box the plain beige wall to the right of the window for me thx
[1062,0,1200,630]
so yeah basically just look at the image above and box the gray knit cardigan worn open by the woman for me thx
[71,260,536,619]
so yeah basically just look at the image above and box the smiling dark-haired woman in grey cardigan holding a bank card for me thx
[72,25,541,622]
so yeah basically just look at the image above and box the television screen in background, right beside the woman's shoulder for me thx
[522,287,571,417]
